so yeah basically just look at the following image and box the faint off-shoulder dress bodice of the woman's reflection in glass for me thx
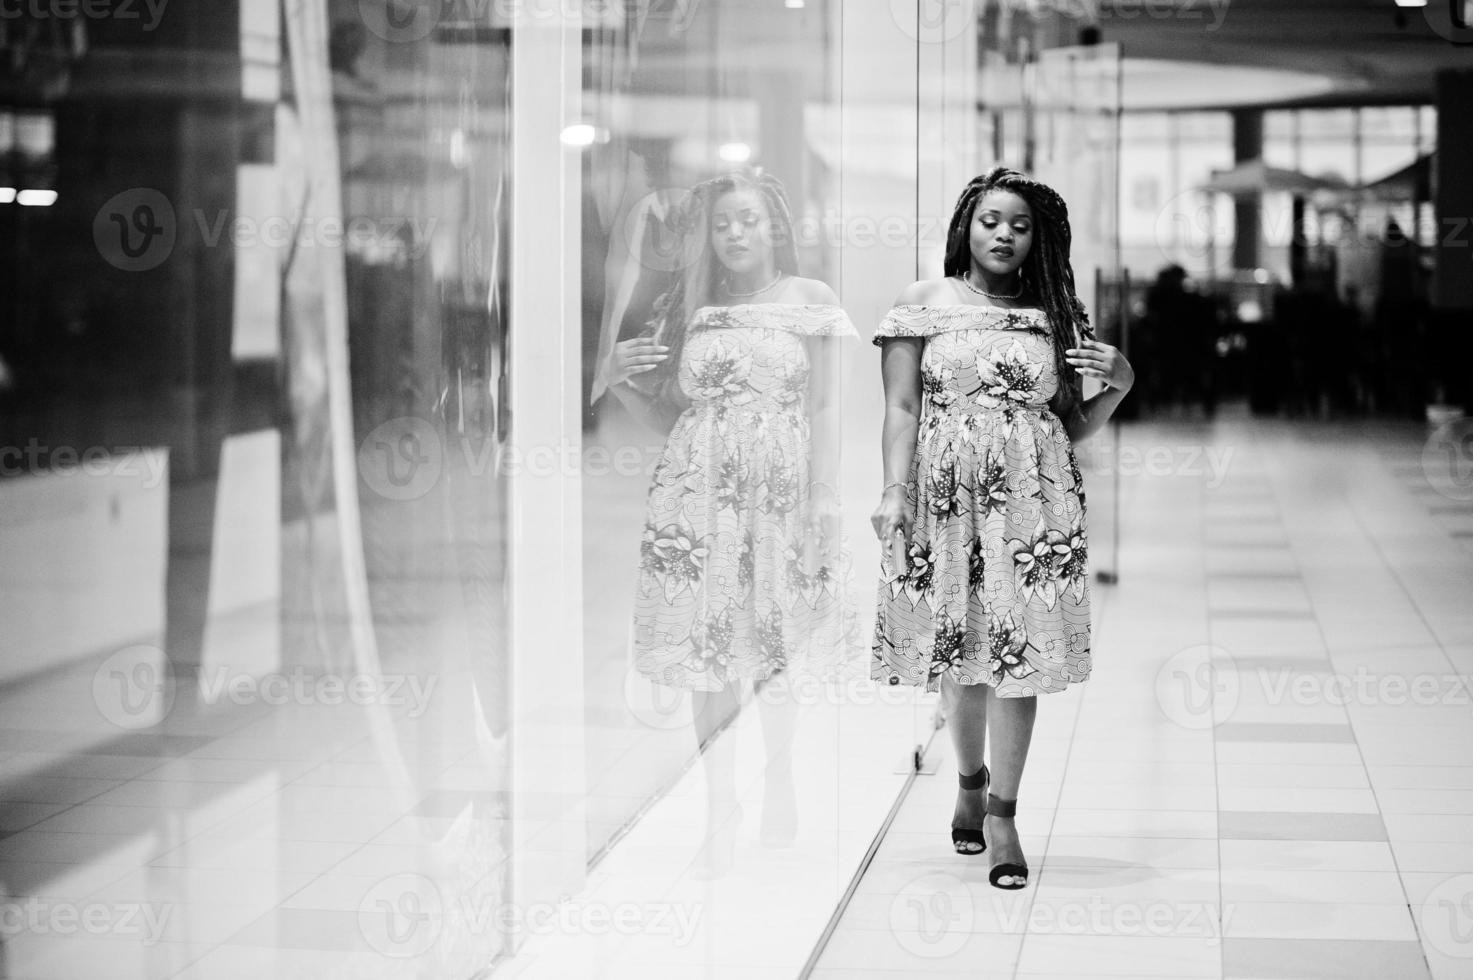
[679,304,857,413]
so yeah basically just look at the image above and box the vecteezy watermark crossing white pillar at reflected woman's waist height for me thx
[358,416,663,501]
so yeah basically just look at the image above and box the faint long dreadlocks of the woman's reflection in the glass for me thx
[647,167,798,404]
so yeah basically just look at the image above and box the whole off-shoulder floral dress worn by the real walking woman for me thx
[871,305,1090,697]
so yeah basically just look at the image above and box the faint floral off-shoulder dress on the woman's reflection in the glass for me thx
[635,304,859,691]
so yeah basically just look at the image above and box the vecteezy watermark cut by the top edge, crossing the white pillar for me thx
[358,0,700,44]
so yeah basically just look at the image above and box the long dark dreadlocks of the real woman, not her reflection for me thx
[944,167,1094,416]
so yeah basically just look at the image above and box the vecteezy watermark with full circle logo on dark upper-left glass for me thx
[92,186,437,273]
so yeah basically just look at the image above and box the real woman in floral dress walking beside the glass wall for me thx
[871,168,1134,889]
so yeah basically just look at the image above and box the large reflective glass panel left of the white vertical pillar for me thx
[0,0,511,977]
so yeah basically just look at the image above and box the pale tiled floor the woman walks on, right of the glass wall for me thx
[813,406,1473,980]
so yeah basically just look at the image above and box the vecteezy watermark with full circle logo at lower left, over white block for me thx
[93,644,439,731]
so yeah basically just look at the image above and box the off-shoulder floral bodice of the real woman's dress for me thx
[875,304,1059,414]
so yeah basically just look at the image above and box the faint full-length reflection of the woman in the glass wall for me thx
[610,171,856,874]
